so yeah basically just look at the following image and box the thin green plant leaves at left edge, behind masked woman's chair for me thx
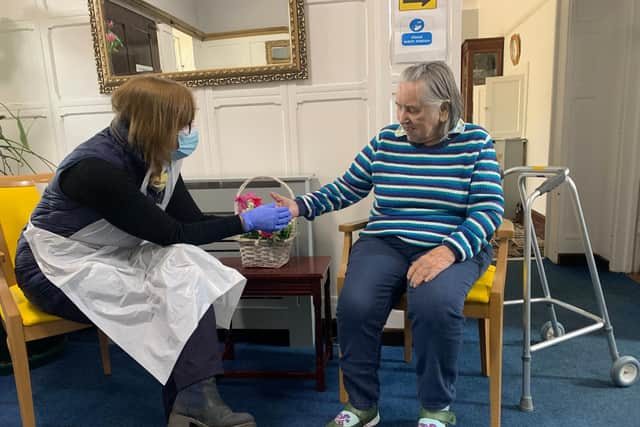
[0,102,56,175]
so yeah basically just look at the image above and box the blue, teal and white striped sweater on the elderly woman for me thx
[296,121,504,261]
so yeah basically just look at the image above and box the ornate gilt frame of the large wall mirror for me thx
[89,0,309,93]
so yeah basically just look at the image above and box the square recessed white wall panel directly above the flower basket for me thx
[215,104,287,176]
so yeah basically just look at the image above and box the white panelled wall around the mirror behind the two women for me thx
[0,0,461,314]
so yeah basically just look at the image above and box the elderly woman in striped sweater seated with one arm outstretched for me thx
[272,62,504,427]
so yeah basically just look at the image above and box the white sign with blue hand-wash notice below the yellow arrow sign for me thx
[393,0,450,63]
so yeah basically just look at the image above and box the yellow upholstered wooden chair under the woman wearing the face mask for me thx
[0,174,111,427]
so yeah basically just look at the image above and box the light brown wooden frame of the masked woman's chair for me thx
[0,174,111,427]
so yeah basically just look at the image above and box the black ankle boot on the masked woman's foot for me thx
[167,377,256,427]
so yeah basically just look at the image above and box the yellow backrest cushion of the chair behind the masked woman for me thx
[0,186,40,264]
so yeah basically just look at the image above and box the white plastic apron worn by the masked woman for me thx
[24,161,246,384]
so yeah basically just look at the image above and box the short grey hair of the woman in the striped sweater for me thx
[401,61,463,130]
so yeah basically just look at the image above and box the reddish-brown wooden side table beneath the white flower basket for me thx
[220,256,333,391]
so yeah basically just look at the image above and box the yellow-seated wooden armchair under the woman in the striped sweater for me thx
[338,220,513,427]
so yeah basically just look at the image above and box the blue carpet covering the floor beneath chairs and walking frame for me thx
[0,262,640,427]
